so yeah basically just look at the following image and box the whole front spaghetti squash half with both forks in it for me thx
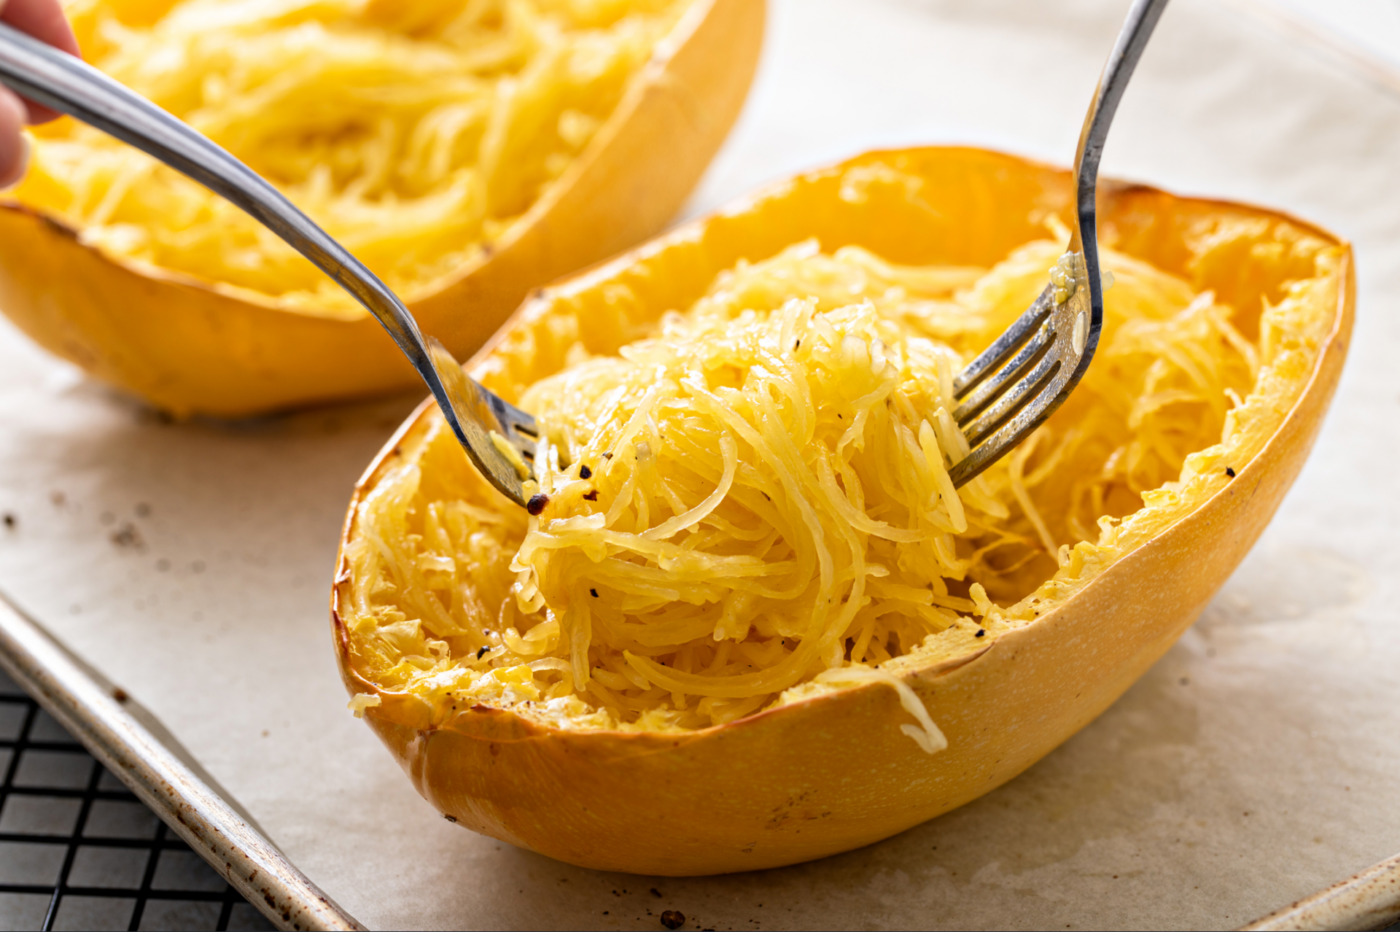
[335,150,1350,873]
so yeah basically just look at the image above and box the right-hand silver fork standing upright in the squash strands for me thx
[949,0,1168,487]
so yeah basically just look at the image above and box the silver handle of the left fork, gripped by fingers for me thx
[0,24,447,409]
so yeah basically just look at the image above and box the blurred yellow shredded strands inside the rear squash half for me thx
[17,0,686,315]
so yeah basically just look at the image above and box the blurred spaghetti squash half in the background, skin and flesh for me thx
[0,0,763,414]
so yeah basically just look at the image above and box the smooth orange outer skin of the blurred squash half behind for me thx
[0,0,764,417]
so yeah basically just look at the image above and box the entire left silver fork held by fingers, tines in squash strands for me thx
[0,24,542,503]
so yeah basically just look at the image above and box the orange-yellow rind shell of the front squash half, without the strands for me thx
[332,148,1355,876]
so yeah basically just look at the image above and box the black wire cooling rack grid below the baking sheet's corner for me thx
[0,673,273,931]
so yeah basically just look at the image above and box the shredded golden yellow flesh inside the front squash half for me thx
[337,177,1344,751]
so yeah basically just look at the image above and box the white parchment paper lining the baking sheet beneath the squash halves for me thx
[0,0,1400,929]
